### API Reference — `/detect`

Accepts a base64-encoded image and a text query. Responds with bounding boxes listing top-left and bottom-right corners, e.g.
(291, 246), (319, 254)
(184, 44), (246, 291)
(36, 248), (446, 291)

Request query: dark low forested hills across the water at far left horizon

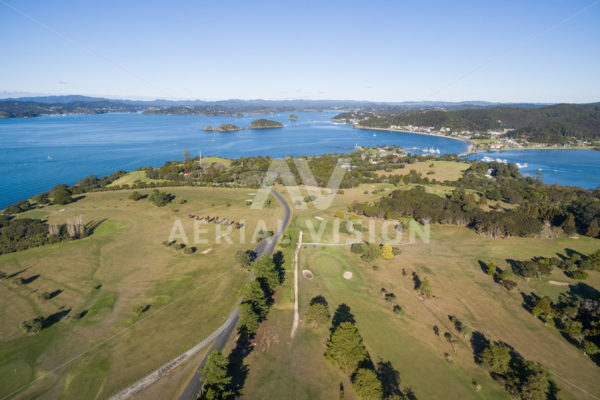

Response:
(0, 99), (140, 118)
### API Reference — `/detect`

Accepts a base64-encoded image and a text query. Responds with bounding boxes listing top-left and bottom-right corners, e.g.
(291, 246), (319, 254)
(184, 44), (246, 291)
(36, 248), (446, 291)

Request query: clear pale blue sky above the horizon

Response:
(0, 0), (600, 102)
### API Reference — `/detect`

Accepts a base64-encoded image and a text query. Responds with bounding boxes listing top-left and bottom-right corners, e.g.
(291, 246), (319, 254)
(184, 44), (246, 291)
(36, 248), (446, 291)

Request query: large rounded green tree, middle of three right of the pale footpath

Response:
(325, 322), (368, 374)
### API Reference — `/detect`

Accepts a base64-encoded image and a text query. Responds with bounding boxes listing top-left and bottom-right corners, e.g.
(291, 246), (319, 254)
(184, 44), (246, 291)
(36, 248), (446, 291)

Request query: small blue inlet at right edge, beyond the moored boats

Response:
(469, 150), (600, 189)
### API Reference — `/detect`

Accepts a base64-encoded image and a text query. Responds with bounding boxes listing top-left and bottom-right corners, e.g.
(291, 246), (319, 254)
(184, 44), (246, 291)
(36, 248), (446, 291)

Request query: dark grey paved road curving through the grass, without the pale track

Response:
(179, 189), (290, 400)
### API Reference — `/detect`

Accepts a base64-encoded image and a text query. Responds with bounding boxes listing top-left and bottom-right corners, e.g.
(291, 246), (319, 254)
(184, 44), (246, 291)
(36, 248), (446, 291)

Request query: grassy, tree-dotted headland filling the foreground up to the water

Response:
(0, 146), (600, 399)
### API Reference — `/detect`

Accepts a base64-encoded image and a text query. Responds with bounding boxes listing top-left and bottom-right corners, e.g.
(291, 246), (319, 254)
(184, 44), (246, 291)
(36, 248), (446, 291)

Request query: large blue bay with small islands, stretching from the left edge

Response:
(0, 112), (466, 208)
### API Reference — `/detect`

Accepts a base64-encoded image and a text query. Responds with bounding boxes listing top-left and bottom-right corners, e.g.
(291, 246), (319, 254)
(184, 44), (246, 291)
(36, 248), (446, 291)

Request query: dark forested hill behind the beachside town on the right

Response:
(335, 103), (600, 143)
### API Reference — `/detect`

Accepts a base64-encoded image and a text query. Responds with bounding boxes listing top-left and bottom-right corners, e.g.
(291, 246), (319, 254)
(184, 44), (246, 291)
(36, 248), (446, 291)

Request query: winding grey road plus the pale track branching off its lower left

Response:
(109, 189), (290, 400)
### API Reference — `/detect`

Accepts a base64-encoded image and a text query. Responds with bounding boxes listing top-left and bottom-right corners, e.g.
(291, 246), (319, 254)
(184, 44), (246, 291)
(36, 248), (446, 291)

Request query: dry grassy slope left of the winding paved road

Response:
(0, 188), (281, 399)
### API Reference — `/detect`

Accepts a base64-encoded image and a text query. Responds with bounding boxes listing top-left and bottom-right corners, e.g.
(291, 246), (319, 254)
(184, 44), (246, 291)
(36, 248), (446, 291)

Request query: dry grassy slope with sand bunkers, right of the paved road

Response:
(238, 190), (600, 399)
